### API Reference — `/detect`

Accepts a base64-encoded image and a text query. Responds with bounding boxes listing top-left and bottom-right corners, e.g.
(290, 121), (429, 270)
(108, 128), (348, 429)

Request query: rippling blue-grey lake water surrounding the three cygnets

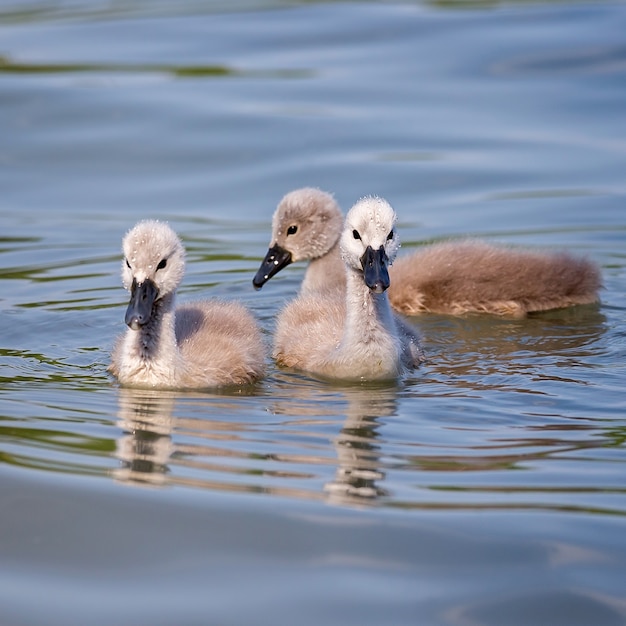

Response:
(0, 0), (626, 626)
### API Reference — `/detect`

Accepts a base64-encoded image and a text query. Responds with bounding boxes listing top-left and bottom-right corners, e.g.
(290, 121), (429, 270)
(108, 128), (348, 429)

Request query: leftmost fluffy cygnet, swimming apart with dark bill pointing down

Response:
(109, 220), (265, 388)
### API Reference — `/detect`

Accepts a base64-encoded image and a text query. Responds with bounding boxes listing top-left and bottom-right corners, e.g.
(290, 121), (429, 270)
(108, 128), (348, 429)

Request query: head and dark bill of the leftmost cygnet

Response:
(122, 220), (185, 330)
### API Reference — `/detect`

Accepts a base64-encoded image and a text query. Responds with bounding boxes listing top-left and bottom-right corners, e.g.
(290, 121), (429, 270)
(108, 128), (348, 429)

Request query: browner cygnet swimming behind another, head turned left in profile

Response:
(253, 188), (601, 317)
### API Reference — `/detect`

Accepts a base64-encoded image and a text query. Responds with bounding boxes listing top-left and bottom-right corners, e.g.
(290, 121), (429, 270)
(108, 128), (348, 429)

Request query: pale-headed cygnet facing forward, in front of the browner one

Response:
(274, 197), (422, 380)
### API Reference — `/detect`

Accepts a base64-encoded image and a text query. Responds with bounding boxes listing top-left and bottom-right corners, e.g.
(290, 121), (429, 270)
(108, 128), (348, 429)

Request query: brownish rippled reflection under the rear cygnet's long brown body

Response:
(414, 305), (607, 395)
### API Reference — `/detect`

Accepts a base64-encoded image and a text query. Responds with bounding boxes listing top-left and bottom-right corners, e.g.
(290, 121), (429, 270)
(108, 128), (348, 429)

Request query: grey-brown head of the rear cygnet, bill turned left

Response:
(252, 187), (343, 289)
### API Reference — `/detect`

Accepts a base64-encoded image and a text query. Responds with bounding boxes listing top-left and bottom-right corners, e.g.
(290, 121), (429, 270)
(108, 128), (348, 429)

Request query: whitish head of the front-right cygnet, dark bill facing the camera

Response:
(340, 197), (400, 293)
